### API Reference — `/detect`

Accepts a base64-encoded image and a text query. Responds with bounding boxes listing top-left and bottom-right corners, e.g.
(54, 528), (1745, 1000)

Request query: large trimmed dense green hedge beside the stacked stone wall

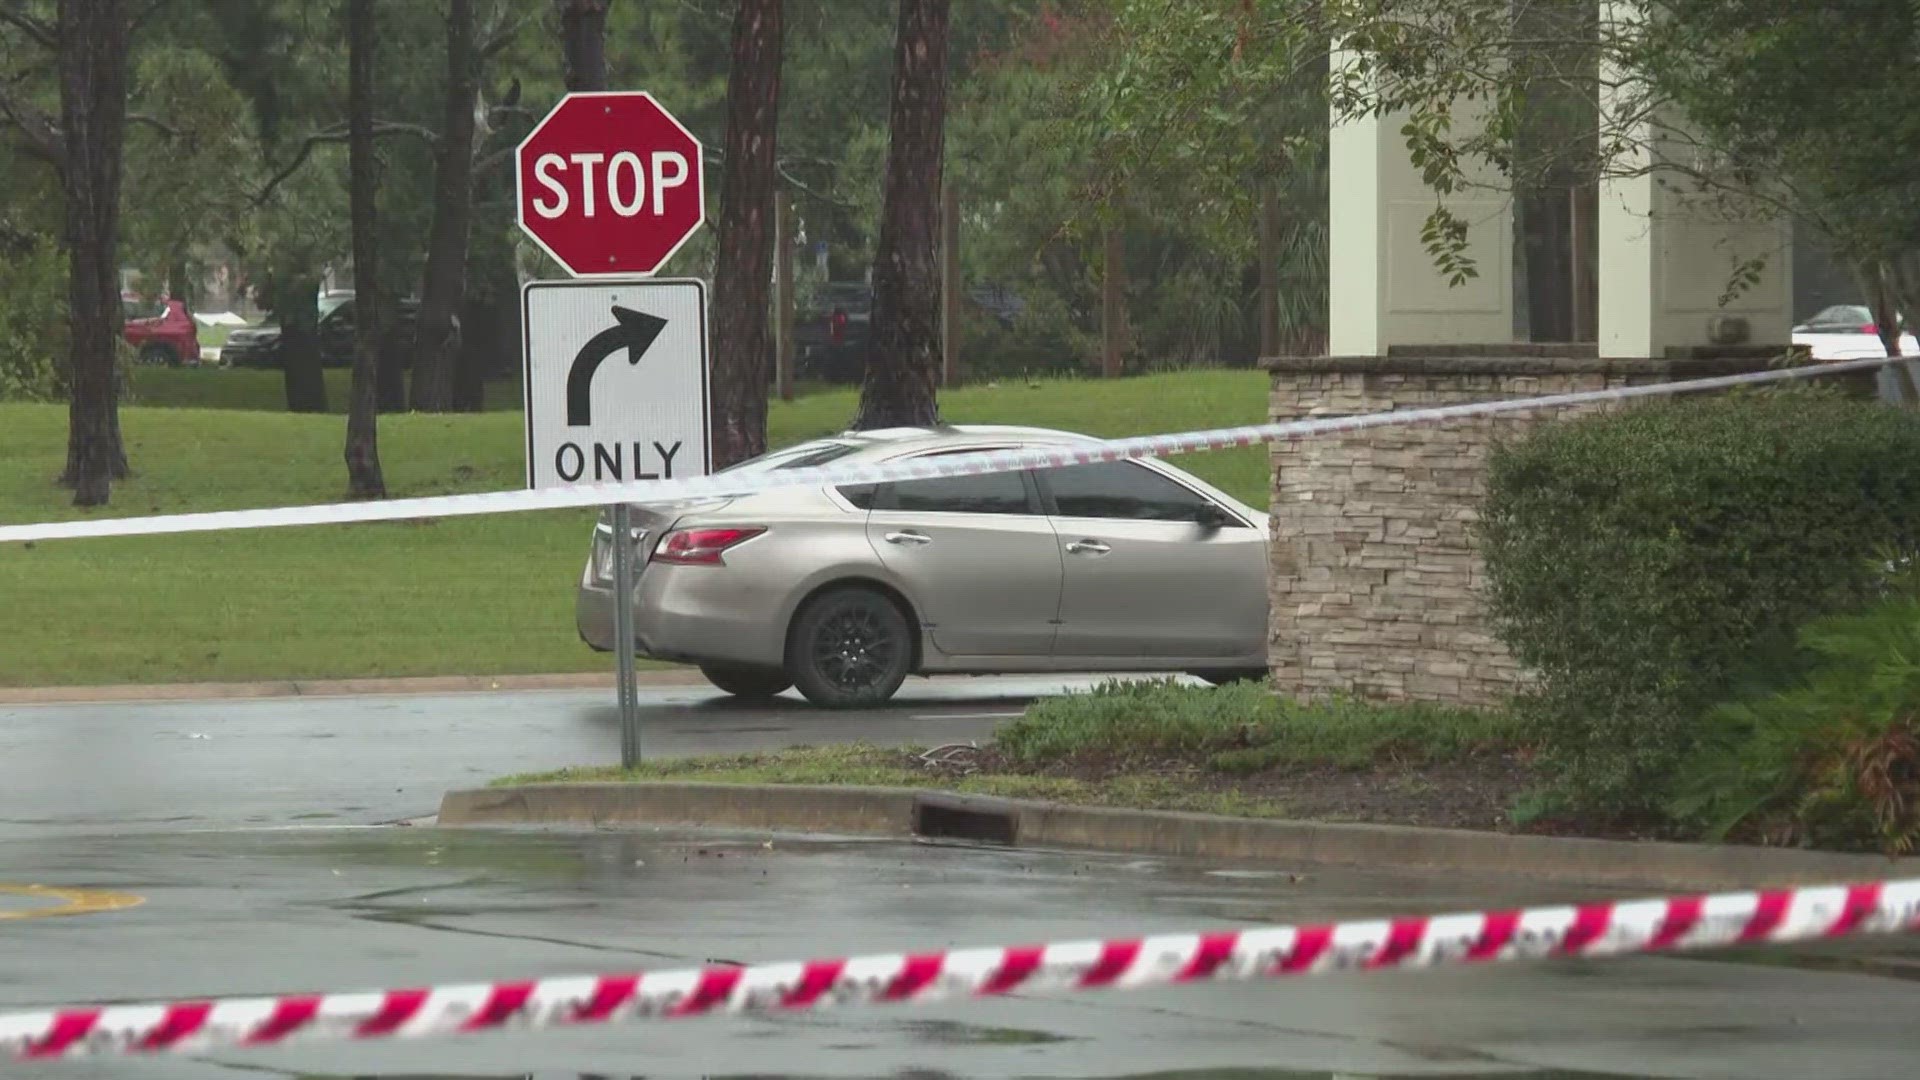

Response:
(1480, 388), (1920, 821)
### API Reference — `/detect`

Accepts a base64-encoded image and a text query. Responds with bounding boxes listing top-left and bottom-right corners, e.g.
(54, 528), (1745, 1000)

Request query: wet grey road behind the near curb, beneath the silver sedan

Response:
(0, 678), (1091, 836)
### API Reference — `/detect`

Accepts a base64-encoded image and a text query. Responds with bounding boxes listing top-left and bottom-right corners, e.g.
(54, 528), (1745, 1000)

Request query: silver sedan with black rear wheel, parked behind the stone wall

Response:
(576, 427), (1267, 709)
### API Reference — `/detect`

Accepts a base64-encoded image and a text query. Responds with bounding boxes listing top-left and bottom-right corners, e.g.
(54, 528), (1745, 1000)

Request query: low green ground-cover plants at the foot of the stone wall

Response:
(995, 680), (1521, 774)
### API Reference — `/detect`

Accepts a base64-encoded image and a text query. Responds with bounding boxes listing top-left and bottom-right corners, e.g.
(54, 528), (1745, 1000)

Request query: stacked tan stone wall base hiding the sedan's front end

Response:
(1267, 346), (1797, 705)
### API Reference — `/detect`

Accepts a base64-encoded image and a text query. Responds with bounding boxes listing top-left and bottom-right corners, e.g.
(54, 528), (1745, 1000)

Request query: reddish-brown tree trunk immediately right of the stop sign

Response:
(712, 0), (783, 469)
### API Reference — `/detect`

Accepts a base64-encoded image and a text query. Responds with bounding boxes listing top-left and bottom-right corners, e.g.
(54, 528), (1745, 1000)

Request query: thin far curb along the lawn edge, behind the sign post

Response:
(0, 669), (705, 705)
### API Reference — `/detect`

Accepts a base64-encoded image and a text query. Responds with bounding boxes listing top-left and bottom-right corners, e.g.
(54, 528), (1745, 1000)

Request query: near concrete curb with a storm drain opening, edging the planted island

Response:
(438, 782), (1920, 890)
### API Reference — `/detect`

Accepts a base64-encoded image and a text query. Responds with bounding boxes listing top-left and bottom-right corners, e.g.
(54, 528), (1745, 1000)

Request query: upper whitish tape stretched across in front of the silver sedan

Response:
(0, 357), (1893, 544)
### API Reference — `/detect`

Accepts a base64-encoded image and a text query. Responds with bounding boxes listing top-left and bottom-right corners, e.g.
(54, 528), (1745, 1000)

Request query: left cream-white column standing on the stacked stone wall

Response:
(1327, 60), (1513, 356)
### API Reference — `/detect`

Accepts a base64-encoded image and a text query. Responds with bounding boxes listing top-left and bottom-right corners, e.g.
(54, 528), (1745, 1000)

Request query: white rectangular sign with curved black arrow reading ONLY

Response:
(522, 279), (712, 488)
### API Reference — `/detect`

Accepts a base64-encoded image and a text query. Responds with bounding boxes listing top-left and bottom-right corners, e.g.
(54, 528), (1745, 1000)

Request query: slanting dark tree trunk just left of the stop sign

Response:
(413, 0), (480, 413)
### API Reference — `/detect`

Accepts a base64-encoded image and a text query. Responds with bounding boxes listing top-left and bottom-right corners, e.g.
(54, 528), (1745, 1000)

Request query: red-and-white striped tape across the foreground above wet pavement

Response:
(0, 868), (1920, 1059)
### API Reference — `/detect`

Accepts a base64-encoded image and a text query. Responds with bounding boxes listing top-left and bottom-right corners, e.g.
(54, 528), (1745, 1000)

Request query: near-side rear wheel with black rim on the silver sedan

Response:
(787, 588), (914, 709)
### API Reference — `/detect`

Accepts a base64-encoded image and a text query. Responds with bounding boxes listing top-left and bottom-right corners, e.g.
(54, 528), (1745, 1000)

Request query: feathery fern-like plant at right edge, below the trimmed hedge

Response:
(1670, 573), (1920, 855)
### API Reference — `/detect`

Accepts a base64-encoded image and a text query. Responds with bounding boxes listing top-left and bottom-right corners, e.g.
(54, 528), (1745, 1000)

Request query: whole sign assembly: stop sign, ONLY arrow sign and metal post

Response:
(515, 92), (712, 769)
